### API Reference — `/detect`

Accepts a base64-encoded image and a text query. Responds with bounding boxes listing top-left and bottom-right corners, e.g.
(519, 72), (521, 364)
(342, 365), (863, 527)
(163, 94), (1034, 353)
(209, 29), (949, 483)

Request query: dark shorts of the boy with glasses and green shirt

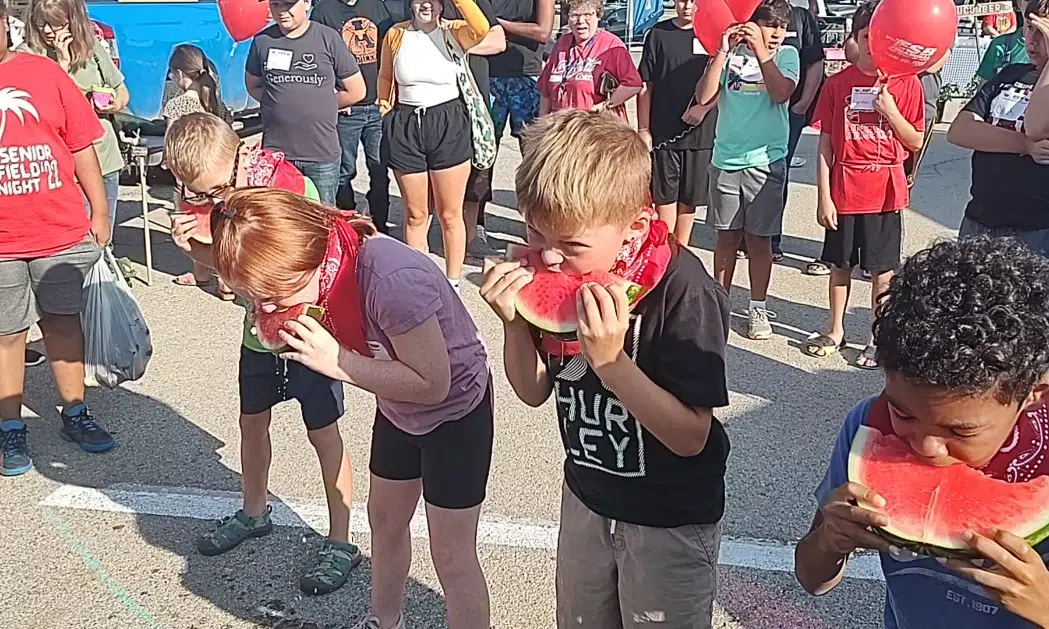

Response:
(239, 346), (346, 430)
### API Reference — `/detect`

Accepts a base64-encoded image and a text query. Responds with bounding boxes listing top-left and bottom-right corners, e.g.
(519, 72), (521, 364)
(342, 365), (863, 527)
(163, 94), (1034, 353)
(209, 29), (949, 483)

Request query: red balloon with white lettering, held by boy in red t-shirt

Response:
(870, 0), (958, 77)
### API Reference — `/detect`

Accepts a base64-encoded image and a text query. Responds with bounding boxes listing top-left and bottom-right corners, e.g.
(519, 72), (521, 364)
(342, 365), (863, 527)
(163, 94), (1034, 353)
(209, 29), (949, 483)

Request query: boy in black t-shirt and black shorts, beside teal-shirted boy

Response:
(638, 0), (716, 244)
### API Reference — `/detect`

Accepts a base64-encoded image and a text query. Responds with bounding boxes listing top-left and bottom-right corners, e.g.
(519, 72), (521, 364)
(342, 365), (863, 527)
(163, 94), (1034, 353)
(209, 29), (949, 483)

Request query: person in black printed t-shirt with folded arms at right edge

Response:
(947, 0), (1049, 256)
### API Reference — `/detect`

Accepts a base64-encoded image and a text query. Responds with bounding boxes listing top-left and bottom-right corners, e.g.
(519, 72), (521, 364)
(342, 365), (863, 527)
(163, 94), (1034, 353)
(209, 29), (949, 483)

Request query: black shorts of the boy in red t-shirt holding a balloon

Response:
(819, 212), (903, 273)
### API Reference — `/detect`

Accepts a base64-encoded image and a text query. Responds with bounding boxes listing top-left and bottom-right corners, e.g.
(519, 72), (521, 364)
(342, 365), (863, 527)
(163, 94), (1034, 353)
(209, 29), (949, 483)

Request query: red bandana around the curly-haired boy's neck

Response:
(865, 396), (1049, 482)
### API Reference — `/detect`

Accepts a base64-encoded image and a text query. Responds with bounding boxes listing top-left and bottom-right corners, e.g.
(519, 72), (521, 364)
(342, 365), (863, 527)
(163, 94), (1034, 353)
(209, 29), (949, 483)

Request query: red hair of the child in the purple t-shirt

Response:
(211, 188), (376, 299)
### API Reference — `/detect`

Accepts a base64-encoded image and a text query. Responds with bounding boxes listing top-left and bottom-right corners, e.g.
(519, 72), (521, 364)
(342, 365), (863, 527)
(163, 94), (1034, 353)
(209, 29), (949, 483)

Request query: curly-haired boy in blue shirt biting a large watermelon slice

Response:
(794, 237), (1049, 629)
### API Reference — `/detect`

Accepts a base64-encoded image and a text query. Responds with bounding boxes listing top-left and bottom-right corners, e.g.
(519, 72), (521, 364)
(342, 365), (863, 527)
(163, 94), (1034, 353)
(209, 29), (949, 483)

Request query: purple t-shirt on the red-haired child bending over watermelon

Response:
(357, 236), (488, 435)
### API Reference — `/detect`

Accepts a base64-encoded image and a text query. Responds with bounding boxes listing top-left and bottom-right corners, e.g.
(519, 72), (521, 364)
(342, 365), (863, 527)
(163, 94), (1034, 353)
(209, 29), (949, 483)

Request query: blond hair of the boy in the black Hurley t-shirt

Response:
(516, 110), (651, 234)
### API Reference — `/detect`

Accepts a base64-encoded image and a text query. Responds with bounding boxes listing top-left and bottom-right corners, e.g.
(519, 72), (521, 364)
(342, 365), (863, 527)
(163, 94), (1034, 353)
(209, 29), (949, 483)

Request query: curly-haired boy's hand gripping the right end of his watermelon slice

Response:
(946, 530), (1049, 627)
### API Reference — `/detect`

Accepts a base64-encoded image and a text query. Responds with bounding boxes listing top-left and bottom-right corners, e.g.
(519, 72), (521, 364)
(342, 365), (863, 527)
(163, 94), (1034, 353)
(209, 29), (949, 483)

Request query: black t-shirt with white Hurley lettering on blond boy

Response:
(547, 248), (729, 528)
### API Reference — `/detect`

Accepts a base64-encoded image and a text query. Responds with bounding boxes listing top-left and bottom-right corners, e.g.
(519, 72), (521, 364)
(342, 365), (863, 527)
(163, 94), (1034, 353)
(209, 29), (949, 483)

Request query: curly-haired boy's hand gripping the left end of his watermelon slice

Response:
(811, 482), (890, 556)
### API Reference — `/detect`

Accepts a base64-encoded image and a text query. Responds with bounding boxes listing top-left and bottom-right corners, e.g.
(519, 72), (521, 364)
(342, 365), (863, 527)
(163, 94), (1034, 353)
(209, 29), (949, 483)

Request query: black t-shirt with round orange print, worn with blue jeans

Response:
(309, 0), (395, 105)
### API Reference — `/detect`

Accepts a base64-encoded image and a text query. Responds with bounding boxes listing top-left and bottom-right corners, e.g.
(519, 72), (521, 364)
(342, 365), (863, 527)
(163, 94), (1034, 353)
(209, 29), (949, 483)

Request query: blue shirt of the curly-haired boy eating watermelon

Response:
(815, 397), (1049, 629)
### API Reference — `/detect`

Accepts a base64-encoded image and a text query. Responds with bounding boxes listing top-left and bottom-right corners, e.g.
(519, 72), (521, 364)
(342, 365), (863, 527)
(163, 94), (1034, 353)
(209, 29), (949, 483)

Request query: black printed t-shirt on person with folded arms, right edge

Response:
(965, 63), (1049, 231)
